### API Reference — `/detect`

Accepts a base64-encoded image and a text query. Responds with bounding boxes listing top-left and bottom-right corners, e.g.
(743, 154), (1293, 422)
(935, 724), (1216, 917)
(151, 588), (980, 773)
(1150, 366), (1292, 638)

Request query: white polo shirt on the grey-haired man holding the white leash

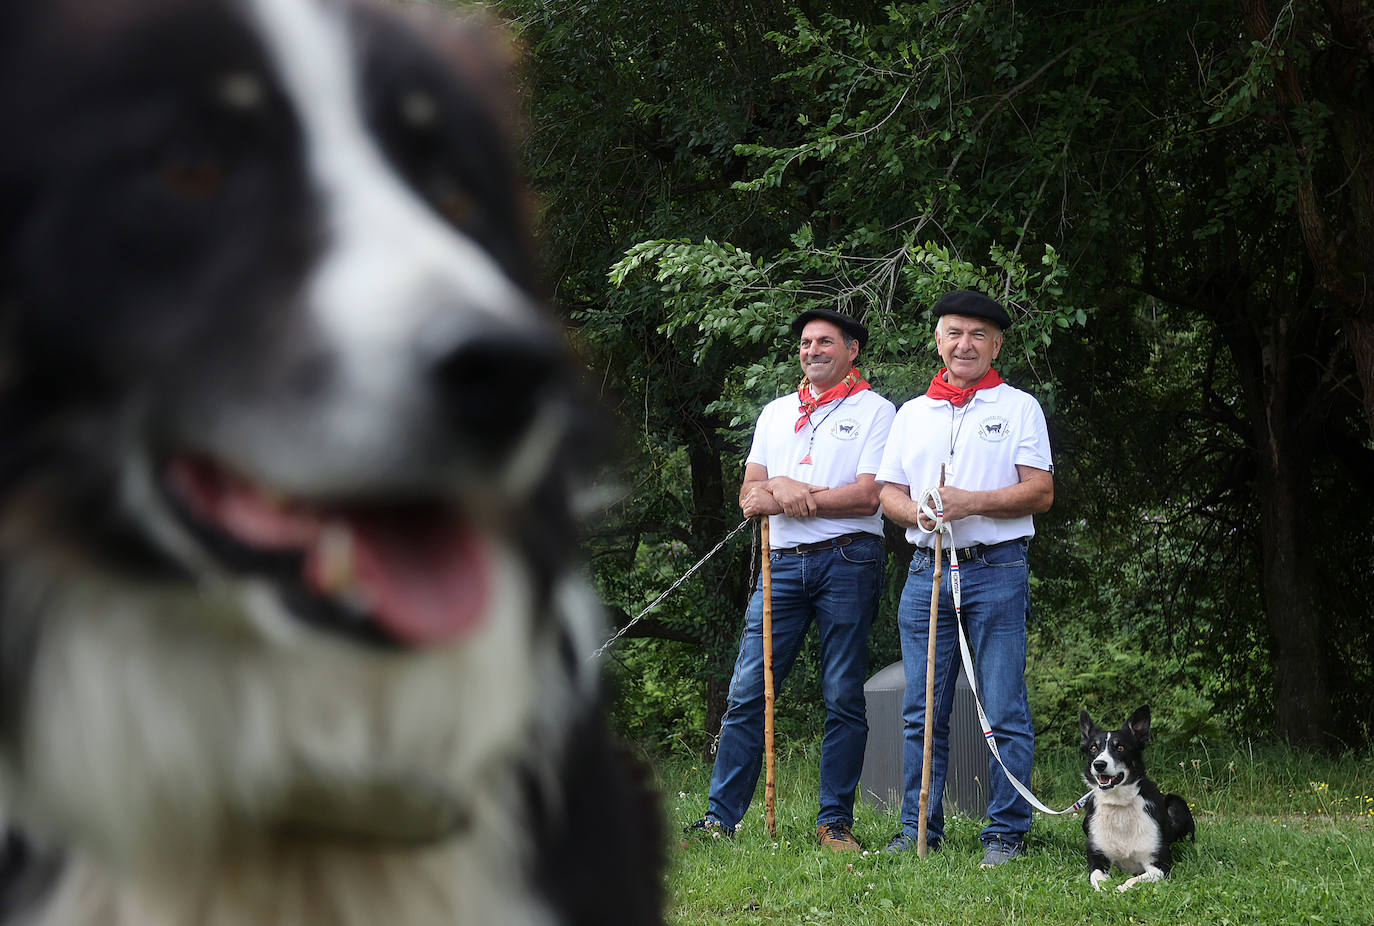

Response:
(878, 383), (1054, 548)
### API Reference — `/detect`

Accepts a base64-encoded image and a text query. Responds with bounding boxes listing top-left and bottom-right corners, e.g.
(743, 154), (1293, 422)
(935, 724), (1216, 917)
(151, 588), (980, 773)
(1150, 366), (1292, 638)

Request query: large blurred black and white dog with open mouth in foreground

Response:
(0, 0), (661, 926)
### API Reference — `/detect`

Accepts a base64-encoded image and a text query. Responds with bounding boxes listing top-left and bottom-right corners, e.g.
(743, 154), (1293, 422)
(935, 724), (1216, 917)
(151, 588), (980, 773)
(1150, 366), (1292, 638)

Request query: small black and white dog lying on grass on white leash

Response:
(1079, 705), (1194, 890)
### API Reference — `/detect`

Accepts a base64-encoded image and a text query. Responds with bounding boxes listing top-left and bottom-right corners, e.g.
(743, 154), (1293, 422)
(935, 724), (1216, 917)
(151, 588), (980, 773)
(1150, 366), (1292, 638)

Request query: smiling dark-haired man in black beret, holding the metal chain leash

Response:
(687, 309), (896, 852)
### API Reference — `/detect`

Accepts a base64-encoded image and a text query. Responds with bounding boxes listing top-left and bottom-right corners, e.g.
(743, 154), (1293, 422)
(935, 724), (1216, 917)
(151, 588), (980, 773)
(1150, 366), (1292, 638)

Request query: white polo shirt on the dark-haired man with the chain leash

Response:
(747, 389), (897, 548)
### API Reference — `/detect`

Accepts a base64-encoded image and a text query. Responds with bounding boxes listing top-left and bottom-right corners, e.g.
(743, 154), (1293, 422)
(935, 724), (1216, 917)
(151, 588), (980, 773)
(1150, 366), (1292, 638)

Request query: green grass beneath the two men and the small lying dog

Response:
(658, 746), (1374, 926)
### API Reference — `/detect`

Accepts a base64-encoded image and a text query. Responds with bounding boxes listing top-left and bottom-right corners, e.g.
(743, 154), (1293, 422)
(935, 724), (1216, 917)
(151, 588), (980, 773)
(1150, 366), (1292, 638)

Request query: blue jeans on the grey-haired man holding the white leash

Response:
(897, 540), (1035, 842)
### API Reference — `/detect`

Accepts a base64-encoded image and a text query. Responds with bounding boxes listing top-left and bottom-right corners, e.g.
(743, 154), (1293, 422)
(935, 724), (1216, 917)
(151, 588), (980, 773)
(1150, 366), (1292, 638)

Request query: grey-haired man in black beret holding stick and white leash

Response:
(878, 290), (1054, 867)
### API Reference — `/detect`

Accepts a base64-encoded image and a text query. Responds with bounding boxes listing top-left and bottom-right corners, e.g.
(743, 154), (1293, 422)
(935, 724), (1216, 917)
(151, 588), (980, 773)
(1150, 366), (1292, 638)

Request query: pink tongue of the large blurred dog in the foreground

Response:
(346, 515), (491, 646)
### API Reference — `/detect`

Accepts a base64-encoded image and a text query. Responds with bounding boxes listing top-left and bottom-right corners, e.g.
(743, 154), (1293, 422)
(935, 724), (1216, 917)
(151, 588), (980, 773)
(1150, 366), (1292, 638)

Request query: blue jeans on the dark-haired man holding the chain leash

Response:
(706, 536), (883, 827)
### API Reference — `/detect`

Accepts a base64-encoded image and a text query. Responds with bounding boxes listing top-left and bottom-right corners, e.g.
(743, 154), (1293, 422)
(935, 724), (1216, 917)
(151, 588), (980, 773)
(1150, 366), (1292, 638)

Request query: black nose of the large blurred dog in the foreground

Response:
(430, 323), (567, 455)
